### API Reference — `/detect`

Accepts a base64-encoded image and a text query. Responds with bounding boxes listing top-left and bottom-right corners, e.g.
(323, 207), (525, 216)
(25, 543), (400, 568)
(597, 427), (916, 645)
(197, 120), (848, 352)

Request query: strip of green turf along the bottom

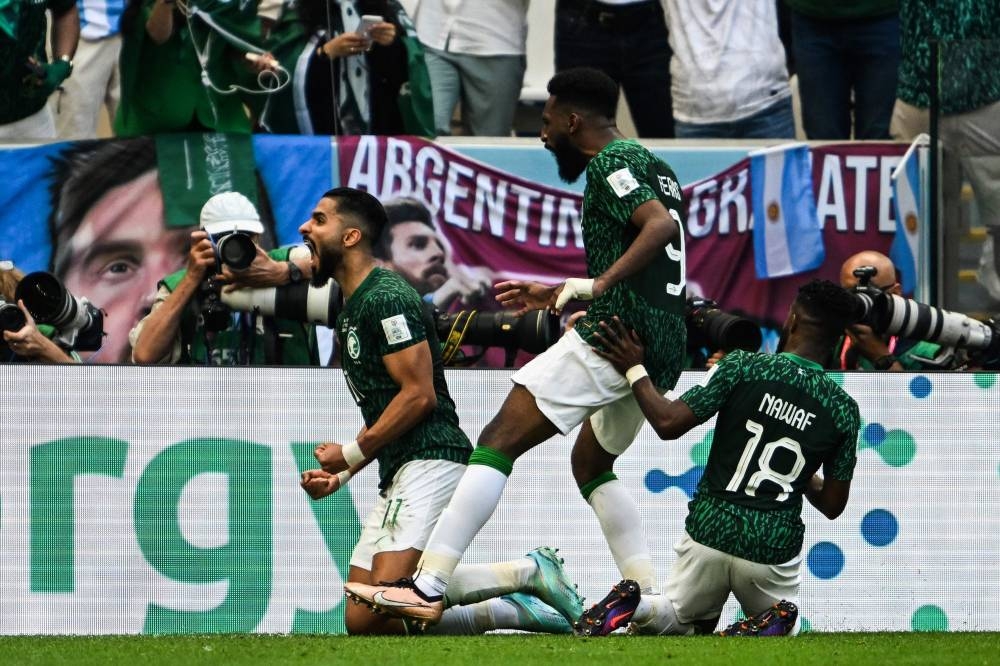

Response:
(0, 633), (1000, 666)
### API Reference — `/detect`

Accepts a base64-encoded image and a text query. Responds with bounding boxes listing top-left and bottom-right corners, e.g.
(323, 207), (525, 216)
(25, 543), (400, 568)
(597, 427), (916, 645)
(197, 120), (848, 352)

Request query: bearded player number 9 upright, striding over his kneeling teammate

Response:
(345, 68), (686, 623)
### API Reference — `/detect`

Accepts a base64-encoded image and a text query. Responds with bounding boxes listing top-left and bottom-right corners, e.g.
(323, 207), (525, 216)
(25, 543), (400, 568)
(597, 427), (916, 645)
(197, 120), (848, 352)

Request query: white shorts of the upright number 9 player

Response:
(511, 329), (645, 455)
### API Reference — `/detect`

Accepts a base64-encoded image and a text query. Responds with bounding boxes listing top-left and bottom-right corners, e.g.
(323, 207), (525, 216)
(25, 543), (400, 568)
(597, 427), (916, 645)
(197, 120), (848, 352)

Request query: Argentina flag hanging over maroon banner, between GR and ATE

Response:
(750, 143), (826, 280)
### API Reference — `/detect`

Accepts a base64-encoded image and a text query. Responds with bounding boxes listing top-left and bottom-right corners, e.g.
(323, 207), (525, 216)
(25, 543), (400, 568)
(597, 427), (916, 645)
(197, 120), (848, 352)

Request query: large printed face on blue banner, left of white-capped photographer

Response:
(63, 171), (190, 363)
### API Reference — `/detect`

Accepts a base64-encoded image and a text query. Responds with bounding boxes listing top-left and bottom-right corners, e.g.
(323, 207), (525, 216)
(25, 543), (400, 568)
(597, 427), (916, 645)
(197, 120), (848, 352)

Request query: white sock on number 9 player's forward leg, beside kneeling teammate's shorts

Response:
(415, 465), (507, 596)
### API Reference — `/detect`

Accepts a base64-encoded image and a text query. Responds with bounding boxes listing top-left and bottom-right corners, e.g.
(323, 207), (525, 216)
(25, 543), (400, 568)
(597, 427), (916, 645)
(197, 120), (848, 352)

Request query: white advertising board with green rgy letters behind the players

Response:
(0, 365), (1000, 634)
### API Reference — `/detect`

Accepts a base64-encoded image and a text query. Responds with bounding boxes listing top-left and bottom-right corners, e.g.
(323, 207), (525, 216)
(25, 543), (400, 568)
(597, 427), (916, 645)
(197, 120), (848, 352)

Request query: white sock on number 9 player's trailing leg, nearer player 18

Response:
(587, 479), (659, 594)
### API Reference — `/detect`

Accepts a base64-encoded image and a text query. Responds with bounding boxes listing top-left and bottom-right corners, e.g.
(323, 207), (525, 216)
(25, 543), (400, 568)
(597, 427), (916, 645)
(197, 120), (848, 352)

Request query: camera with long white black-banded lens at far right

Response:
(852, 266), (1000, 356)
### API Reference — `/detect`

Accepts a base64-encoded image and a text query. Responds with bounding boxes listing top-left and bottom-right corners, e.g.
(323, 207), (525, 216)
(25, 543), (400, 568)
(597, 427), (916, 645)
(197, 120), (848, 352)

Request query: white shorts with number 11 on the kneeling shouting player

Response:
(351, 460), (465, 571)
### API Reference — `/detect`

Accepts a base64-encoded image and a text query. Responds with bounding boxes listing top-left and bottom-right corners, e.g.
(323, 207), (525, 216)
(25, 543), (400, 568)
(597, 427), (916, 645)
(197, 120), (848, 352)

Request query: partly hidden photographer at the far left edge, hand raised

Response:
(0, 261), (79, 363)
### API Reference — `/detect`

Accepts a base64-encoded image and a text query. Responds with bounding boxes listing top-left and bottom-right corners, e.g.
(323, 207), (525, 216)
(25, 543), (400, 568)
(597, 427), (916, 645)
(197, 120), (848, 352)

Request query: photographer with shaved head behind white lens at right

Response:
(828, 250), (950, 372)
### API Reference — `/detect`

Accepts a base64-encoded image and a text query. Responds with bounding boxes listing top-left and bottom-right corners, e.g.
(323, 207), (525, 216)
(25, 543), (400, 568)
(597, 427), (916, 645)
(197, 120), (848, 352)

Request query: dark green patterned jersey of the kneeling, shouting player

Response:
(337, 268), (472, 488)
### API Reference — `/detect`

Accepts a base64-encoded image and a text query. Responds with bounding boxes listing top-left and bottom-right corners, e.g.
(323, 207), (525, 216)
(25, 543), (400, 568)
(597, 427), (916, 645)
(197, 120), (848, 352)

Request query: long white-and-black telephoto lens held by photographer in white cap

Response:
(220, 280), (340, 327)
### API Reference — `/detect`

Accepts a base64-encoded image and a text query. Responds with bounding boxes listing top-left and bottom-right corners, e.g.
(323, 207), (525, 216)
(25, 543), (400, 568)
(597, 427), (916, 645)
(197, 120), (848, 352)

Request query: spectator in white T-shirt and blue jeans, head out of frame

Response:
(666, 0), (795, 139)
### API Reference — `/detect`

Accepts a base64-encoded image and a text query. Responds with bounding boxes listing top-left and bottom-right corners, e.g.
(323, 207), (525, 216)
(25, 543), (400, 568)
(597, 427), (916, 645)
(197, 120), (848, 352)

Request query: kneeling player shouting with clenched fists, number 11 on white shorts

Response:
(299, 187), (583, 634)
